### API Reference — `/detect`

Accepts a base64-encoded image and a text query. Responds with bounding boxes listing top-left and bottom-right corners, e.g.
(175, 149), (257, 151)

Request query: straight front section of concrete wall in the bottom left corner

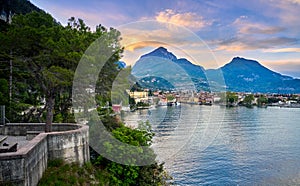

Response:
(0, 133), (48, 185)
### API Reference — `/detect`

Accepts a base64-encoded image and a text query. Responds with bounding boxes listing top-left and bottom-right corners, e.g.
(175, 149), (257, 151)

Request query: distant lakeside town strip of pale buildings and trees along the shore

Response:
(112, 89), (300, 113)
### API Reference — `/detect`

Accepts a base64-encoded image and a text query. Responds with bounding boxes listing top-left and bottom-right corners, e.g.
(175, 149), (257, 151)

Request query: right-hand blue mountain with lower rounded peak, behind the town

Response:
(206, 57), (300, 93)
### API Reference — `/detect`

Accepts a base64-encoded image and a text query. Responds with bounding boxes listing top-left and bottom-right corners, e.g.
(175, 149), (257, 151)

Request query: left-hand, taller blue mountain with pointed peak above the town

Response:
(132, 47), (208, 89)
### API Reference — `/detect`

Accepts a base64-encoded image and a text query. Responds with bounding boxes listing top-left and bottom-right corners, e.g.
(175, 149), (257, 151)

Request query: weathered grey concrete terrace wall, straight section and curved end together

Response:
(0, 124), (89, 186)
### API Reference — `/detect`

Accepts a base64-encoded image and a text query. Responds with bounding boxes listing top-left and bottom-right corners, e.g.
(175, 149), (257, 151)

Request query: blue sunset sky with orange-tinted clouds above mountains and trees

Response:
(31, 0), (300, 78)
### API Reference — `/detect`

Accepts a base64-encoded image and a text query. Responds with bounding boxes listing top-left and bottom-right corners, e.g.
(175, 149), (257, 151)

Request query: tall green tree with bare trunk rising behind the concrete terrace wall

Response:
(4, 12), (73, 132)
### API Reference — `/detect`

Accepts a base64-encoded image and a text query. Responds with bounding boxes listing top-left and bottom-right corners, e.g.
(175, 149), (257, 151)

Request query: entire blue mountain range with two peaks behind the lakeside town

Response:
(132, 47), (300, 93)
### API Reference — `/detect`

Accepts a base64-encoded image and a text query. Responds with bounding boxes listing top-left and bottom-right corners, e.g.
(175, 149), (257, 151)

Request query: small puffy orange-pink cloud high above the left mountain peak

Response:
(155, 9), (211, 29)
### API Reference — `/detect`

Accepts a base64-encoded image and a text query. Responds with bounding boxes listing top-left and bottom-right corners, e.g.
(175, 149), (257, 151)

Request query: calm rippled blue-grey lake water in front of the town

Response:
(123, 104), (300, 185)
